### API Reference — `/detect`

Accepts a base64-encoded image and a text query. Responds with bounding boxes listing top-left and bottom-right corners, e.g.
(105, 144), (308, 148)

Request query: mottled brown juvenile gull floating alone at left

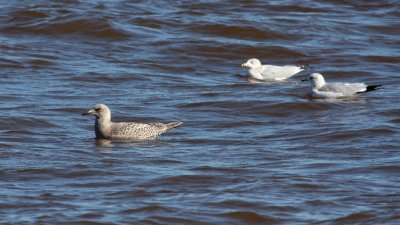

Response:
(82, 104), (182, 141)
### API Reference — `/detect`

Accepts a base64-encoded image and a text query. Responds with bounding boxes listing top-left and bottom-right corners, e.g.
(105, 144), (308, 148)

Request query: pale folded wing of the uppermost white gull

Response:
(261, 65), (303, 80)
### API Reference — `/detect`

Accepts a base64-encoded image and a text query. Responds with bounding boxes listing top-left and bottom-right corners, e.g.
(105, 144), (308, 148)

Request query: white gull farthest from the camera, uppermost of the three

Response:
(242, 58), (306, 81)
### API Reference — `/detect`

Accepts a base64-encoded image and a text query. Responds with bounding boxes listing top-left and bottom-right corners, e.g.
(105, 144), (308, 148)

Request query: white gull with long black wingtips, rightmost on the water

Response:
(302, 73), (382, 98)
